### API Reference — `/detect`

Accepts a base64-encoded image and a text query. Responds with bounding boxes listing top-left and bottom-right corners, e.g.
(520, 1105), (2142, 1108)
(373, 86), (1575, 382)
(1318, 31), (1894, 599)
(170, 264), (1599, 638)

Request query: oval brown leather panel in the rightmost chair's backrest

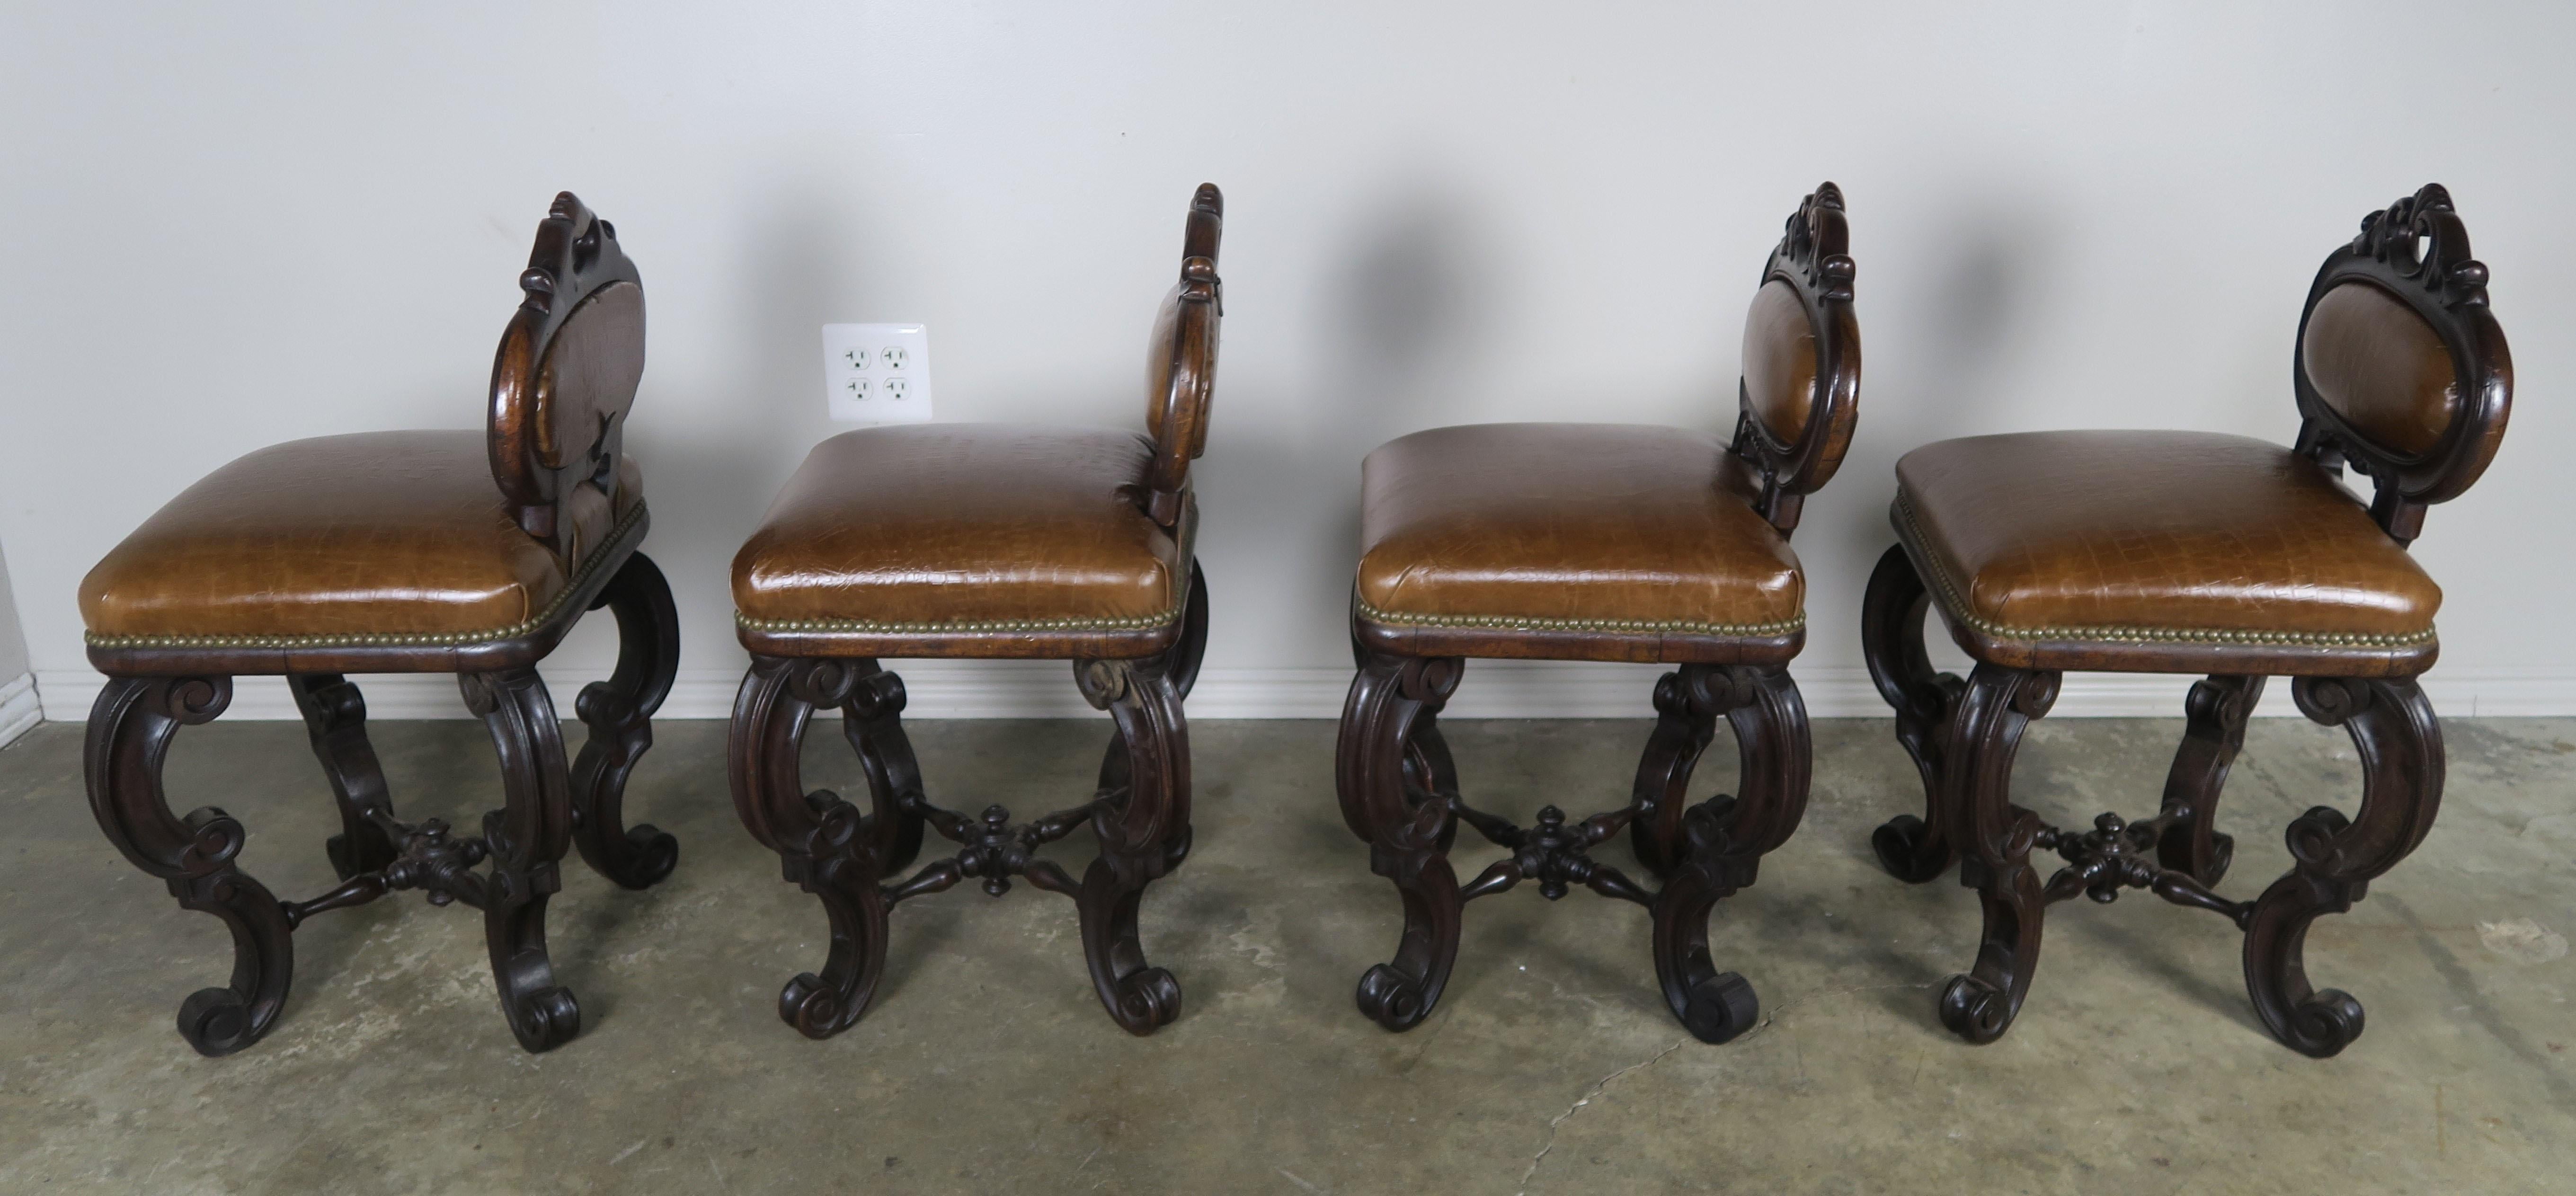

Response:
(2298, 283), (2460, 454)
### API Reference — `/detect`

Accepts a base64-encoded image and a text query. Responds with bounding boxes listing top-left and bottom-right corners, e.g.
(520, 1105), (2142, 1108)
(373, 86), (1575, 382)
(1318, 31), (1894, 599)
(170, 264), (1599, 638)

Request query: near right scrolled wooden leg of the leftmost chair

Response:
(456, 668), (582, 1052)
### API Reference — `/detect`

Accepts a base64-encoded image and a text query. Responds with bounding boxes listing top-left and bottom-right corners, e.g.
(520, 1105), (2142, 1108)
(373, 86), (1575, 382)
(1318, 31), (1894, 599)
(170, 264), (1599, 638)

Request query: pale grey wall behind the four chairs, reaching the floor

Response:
(0, 0), (2576, 717)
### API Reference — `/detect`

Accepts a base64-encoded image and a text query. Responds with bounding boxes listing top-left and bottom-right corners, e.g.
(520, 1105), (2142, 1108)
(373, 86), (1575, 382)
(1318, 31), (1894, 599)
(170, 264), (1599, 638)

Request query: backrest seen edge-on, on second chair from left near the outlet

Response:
(1144, 183), (1226, 528)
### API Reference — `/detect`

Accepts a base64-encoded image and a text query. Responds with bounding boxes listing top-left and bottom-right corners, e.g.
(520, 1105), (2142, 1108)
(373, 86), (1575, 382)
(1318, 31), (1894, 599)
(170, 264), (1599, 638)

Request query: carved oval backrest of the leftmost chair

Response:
(489, 191), (644, 559)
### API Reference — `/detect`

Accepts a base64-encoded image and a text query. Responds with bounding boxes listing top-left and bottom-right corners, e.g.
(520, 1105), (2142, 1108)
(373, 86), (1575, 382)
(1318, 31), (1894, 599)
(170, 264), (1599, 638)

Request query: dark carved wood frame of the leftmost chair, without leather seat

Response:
(85, 191), (680, 1054)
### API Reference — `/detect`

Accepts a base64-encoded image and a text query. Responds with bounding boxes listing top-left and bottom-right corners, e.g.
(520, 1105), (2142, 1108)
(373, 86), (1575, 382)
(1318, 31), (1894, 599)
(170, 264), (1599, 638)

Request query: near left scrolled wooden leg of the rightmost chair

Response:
(1940, 665), (2058, 1044)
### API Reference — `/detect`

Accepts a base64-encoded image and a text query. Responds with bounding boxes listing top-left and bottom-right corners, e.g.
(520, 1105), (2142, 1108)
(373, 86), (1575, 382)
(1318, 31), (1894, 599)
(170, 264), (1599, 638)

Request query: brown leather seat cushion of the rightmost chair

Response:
(1896, 431), (2442, 668)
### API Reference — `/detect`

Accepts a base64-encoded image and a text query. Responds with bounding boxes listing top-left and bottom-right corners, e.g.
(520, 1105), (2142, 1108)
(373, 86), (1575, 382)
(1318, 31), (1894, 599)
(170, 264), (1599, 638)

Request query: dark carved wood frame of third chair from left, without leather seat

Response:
(1334, 183), (1860, 1041)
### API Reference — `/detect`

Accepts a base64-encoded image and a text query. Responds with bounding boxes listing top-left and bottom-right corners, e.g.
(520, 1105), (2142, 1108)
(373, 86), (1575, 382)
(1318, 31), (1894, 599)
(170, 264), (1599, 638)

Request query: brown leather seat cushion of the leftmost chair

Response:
(80, 431), (644, 647)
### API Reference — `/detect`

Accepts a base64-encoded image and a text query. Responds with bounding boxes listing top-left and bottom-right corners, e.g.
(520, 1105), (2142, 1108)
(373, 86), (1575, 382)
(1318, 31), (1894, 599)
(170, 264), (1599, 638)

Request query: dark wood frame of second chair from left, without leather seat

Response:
(729, 186), (1224, 1039)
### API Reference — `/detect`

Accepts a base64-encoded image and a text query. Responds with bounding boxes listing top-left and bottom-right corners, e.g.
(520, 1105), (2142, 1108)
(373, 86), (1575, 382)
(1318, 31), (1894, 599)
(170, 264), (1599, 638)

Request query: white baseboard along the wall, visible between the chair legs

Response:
(35, 660), (2576, 721)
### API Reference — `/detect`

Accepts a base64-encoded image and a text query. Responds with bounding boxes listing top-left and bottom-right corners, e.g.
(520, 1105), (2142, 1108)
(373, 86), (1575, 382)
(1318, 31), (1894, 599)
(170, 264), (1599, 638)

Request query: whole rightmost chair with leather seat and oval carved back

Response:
(1863, 186), (2514, 1057)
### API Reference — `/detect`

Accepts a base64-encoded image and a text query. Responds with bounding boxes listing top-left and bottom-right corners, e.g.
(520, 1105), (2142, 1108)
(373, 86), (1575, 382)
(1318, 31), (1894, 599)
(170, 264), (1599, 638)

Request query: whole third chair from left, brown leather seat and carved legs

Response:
(1334, 183), (1860, 1041)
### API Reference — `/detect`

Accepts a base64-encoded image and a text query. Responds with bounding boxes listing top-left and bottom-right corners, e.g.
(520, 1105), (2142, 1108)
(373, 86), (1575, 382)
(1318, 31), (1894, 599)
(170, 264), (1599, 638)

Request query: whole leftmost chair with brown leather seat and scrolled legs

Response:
(80, 191), (680, 1054)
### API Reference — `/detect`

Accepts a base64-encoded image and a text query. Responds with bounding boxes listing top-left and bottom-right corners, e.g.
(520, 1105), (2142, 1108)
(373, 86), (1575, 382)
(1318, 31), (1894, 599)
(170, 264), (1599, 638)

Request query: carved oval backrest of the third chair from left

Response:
(1733, 183), (1860, 533)
